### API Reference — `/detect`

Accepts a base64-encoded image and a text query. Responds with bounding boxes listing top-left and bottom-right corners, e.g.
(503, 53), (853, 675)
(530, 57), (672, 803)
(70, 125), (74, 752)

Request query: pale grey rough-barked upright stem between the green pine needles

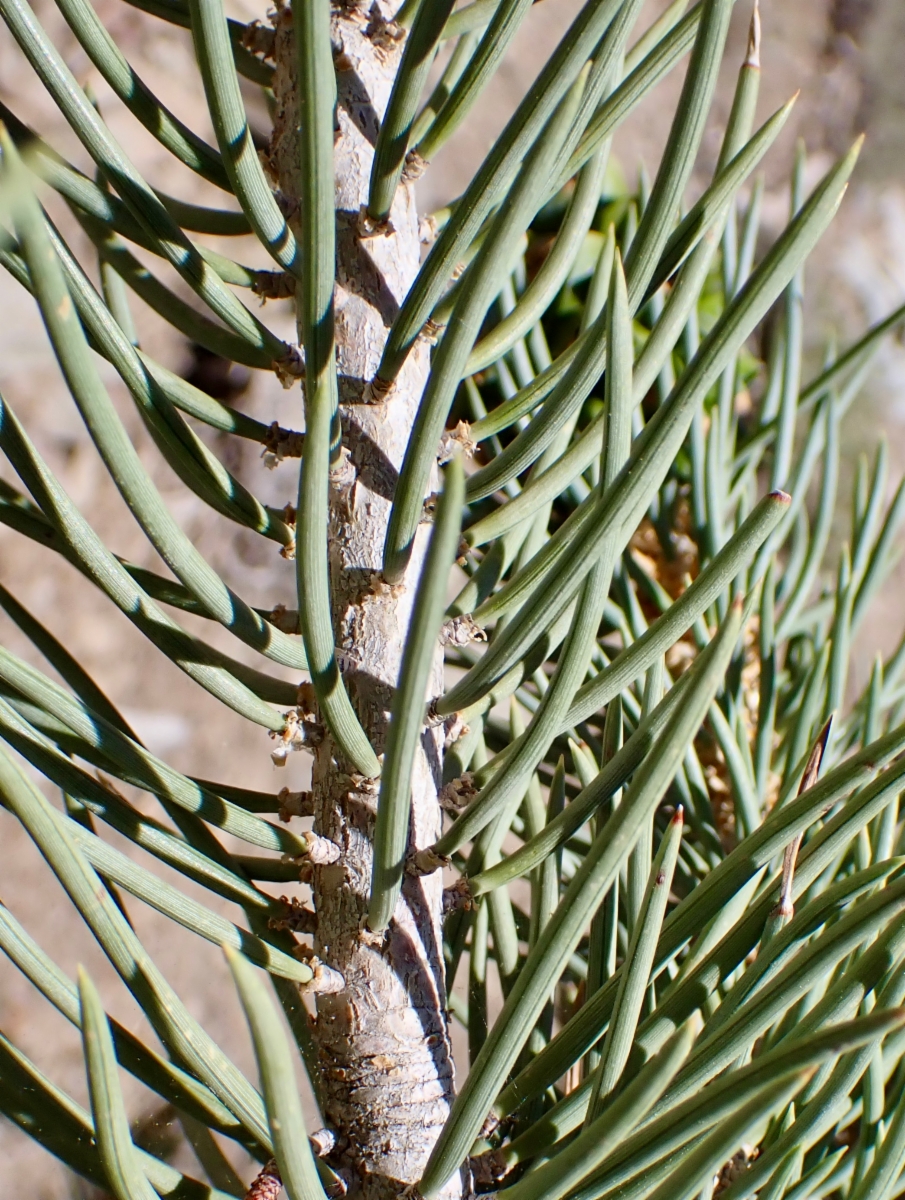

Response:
(269, 0), (453, 1200)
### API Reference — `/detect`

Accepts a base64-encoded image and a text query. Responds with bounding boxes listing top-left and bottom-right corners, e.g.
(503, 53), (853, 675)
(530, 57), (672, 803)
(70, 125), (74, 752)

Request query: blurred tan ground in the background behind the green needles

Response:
(0, 0), (905, 1200)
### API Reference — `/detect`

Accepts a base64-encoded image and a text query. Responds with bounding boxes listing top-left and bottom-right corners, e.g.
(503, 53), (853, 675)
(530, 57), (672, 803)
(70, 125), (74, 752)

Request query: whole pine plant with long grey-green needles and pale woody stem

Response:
(0, 0), (905, 1200)
